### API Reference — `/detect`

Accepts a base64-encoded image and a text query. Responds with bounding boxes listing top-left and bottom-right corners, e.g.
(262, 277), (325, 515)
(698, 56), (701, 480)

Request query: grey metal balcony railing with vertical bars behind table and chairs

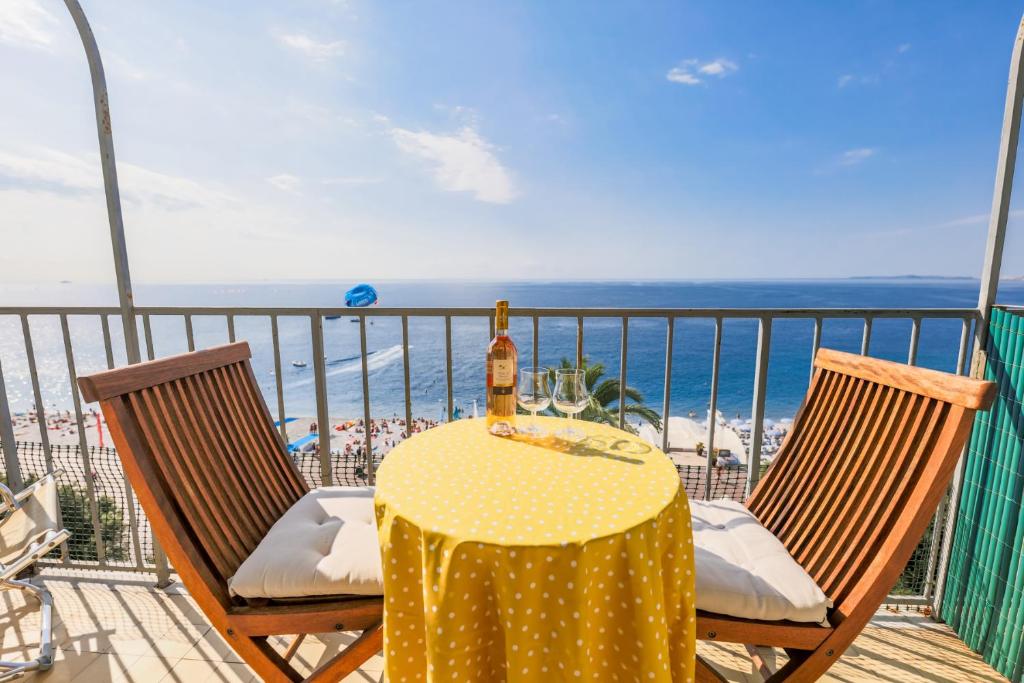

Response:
(0, 306), (979, 602)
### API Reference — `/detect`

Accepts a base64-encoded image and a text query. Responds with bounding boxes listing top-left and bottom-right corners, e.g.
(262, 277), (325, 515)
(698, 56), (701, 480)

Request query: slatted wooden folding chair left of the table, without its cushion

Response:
(79, 342), (383, 682)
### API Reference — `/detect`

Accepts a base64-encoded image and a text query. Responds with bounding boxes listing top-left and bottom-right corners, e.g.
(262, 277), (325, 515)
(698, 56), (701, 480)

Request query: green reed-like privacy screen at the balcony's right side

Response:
(942, 309), (1024, 682)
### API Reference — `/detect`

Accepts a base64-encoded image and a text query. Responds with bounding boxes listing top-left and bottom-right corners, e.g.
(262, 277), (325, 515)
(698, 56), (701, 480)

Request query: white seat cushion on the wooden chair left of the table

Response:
(227, 486), (384, 598)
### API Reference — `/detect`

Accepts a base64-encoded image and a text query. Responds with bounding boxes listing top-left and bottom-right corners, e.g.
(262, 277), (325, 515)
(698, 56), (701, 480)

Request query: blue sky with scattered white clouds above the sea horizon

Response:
(0, 0), (1024, 283)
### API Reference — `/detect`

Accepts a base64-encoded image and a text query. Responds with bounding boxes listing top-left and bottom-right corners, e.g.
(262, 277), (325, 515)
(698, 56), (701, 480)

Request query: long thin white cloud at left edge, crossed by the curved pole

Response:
(0, 147), (233, 210)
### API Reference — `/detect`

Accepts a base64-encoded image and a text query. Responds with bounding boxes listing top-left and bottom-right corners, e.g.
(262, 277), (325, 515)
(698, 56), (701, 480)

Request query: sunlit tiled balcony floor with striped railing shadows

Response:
(0, 572), (1006, 683)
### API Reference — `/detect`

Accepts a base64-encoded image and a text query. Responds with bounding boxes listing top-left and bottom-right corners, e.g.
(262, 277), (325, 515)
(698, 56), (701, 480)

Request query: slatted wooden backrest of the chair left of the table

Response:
(79, 342), (308, 605)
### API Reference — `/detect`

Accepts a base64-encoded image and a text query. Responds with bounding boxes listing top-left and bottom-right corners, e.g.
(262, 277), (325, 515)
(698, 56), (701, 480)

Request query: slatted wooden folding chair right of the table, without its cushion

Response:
(697, 349), (996, 682)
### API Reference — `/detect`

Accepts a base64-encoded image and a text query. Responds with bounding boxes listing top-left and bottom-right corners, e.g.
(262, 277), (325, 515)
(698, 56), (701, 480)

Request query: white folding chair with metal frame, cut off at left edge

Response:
(0, 472), (71, 681)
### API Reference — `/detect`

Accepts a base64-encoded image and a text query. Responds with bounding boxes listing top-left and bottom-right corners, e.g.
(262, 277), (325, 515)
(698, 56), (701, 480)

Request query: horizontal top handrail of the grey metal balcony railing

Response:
(114, 306), (978, 319)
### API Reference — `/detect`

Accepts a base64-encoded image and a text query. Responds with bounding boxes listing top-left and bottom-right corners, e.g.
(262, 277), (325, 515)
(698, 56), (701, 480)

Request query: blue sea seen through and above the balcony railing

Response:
(0, 278), (1024, 420)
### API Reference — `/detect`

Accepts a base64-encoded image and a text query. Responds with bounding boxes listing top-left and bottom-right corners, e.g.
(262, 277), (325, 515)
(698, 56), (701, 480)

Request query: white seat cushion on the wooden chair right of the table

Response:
(690, 500), (831, 625)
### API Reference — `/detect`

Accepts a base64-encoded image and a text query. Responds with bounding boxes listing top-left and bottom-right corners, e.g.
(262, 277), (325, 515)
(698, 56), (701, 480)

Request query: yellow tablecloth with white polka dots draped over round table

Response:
(375, 418), (696, 683)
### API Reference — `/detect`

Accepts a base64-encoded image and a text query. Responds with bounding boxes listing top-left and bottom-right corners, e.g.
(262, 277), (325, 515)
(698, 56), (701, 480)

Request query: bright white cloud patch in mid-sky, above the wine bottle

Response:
(390, 126), (518, 204)
